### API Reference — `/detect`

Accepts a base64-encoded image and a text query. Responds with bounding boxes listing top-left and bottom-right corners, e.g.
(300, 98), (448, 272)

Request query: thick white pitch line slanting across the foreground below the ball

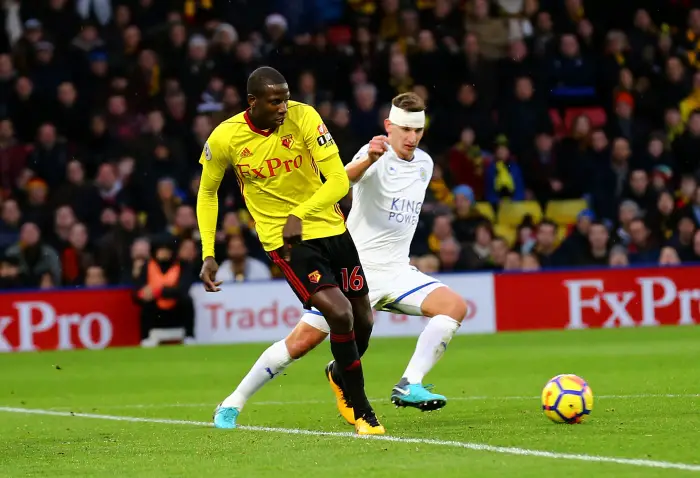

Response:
(0, 407), (700, 472)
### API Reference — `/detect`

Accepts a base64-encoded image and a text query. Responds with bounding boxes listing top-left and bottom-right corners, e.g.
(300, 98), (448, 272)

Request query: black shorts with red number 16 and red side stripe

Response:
(268, 231), (369, 309)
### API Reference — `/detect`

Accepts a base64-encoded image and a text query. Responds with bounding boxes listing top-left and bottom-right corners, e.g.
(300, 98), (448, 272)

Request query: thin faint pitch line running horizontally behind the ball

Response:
(42, 393), (700, 410)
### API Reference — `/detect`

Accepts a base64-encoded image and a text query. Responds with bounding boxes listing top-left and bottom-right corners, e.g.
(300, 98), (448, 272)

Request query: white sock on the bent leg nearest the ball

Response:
(403, 315), (461, 383)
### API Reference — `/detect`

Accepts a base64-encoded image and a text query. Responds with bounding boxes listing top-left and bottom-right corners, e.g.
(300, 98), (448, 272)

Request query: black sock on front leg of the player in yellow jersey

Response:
(331, 332), (372, 418)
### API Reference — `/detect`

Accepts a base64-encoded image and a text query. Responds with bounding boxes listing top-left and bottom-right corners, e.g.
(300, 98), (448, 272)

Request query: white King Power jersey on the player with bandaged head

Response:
(347, 144), (433, 270)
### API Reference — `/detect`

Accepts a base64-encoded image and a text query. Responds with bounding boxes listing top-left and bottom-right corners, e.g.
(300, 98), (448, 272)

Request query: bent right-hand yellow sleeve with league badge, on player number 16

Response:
(290, 106), (350, 220)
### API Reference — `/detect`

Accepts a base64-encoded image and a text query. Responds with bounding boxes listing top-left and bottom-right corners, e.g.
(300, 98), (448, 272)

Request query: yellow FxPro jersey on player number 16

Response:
(198, 101), (347, 257)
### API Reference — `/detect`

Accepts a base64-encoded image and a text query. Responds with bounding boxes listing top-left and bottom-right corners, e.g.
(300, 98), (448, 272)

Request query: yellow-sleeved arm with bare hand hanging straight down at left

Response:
(197, 131), (226, 292)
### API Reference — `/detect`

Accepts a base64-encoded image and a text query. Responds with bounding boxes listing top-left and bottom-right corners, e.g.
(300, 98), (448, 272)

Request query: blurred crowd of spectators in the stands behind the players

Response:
(0, 0), (700, 288)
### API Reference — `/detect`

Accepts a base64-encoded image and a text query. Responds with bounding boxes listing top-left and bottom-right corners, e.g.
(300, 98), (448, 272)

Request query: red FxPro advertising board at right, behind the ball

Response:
(495, 267), (700, 331)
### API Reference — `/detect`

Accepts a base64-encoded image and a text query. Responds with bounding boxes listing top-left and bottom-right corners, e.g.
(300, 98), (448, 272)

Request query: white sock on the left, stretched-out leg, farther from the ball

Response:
(221, 340), (293, 411)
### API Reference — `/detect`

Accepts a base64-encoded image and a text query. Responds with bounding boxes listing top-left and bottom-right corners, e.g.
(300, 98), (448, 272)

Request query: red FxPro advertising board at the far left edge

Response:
(0, 289), (141, 352)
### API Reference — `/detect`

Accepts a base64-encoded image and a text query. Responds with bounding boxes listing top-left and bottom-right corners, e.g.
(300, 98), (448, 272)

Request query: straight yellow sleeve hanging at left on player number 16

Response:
(197, 128), (229, 259)
